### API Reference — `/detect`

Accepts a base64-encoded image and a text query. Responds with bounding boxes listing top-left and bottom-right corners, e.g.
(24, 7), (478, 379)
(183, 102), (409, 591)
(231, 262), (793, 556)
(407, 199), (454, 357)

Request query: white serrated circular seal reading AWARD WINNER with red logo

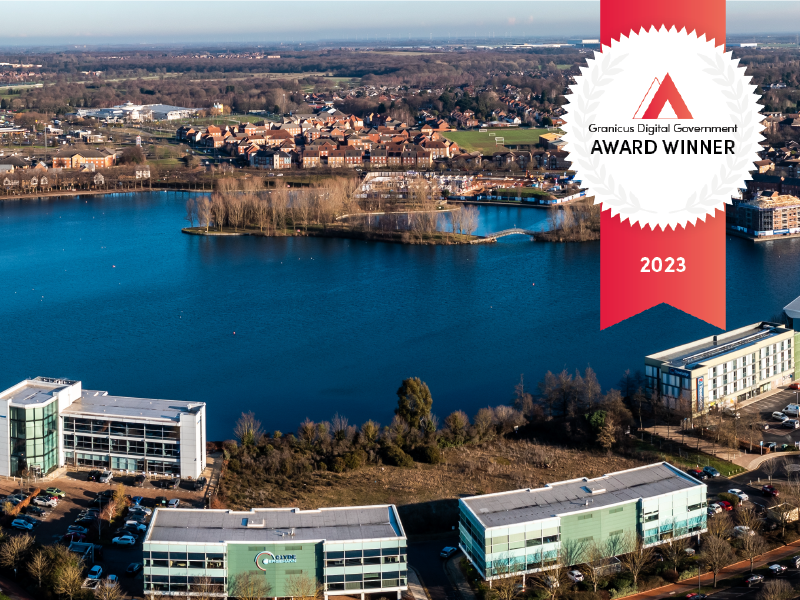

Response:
(563, 27), (763, 229)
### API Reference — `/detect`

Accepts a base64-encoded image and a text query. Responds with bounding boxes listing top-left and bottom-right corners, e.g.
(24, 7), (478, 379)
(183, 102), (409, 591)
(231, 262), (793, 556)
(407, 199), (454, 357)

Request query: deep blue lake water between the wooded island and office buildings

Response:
(0, 193), (800, 439)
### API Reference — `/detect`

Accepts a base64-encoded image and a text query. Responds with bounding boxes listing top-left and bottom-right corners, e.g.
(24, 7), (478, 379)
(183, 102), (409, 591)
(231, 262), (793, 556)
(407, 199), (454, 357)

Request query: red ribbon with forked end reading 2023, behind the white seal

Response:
(600, 0), (725, 329)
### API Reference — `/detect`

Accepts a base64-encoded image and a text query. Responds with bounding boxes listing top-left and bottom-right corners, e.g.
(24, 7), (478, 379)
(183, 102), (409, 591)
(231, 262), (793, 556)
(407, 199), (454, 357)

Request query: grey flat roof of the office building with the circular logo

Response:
(145, 504), (405, 544)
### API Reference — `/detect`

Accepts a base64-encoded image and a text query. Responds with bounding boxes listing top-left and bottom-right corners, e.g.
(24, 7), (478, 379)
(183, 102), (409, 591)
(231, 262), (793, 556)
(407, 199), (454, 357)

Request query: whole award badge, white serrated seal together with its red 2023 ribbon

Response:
(563, 0), (763, 329)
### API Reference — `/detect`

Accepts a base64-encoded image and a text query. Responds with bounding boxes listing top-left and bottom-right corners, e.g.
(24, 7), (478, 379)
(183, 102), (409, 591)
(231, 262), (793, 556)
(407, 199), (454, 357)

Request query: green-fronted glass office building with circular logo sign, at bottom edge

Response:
(143, 505), (408, 600)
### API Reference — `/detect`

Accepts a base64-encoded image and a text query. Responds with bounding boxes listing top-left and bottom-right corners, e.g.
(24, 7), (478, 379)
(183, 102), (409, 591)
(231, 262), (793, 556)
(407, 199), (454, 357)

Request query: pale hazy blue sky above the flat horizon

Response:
(0, 0), (800, 47)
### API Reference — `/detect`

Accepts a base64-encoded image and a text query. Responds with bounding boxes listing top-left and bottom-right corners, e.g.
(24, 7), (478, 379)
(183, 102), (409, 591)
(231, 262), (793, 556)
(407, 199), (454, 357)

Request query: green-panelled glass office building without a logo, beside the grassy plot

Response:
(459, 462), (706, 581)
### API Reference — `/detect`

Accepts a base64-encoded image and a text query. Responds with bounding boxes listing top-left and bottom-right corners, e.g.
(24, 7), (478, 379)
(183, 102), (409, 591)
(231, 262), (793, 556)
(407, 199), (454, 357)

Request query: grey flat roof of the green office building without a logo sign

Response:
(462, 462), (703, 529)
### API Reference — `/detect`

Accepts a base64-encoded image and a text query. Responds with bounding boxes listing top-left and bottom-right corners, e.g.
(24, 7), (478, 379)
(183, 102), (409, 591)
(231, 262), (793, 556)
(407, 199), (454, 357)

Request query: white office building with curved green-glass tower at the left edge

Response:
(0, 377), (206, 479)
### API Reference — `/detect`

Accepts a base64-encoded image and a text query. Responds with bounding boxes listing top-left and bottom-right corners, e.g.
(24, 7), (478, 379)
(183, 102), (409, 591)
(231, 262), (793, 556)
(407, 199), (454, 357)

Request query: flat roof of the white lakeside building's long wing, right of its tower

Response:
(61, 390), (203, 421)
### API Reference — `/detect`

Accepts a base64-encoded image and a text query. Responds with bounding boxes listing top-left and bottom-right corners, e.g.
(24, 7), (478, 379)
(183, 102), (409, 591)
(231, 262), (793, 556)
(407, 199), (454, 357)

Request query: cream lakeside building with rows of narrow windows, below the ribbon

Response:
(644, 321), (795, 415)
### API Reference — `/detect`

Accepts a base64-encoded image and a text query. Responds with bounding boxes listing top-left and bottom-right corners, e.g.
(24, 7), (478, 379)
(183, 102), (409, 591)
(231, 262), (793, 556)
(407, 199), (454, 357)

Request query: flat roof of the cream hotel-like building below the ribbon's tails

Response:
(647, 321), (792, 370)
